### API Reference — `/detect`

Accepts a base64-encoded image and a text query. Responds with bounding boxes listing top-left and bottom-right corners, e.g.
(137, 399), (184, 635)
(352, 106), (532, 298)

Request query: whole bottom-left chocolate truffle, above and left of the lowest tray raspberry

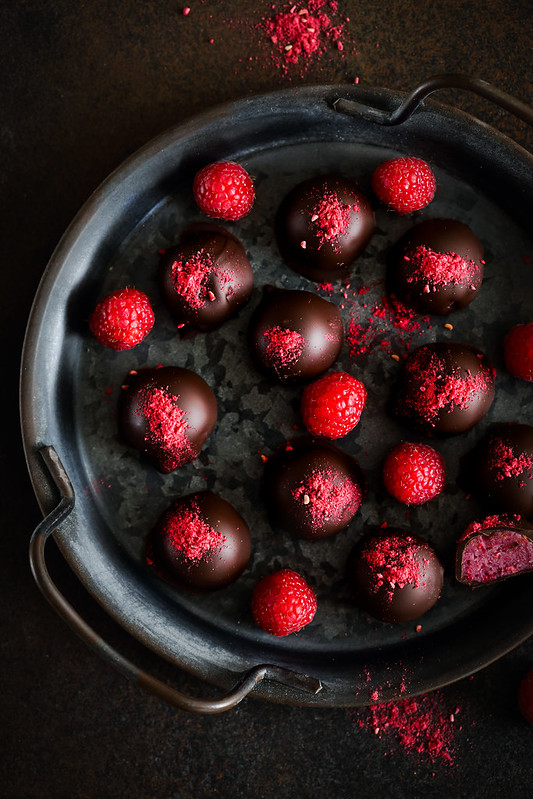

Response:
(146, 491), (252, 591)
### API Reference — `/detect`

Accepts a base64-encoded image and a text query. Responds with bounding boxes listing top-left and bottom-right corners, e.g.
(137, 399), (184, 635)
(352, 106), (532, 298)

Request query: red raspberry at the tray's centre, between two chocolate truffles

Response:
(301, 372), (366, 438)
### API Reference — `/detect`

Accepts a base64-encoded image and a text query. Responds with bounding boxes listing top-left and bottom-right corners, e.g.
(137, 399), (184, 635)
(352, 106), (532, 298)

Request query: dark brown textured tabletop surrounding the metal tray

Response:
(0, 0), (533, 799)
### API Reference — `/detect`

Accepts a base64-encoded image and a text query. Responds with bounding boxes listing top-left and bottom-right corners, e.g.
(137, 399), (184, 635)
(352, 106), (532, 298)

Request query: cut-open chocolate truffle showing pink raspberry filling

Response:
(455, 516), (533, 587)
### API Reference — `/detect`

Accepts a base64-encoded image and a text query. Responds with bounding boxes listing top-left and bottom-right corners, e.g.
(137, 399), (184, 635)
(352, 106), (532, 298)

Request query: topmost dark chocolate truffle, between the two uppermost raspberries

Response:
(275, 175), (375, 283)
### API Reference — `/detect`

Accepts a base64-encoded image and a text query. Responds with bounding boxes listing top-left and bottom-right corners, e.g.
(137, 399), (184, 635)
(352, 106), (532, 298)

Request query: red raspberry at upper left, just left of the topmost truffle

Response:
(192, 161), (255, 221)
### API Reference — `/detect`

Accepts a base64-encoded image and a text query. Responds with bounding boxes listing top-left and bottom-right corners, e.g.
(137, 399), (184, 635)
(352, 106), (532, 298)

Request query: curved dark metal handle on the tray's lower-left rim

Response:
(29, 446), (322, 714)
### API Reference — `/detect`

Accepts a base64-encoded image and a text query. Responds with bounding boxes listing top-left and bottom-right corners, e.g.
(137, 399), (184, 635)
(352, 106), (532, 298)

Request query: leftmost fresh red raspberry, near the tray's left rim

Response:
(89, 288), (154, 350)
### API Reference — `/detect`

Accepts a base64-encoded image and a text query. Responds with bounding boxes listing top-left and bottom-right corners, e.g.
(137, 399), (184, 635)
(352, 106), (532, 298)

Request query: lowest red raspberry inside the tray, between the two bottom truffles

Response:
(252, 569), (317, 636)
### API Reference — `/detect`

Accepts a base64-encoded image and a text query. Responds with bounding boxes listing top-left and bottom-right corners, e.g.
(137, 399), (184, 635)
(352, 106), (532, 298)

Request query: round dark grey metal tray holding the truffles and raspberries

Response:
(21, 79), (533, 712)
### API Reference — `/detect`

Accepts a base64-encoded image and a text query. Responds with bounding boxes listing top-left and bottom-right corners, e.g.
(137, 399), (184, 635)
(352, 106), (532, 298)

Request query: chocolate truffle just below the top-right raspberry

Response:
(388, 219), (483, 316)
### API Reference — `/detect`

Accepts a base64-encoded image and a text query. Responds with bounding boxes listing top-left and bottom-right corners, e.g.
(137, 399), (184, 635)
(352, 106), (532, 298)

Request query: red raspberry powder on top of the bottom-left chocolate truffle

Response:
(158, 502), (226, 560)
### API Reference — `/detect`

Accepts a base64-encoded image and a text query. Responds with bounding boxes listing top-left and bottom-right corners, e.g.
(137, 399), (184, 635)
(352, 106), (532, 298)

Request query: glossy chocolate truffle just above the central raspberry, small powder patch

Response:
(248, 286), (344, 381)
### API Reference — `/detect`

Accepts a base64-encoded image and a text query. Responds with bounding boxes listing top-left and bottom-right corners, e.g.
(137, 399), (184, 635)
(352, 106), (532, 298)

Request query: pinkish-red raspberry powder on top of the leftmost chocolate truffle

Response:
(141, 388), (195, 469)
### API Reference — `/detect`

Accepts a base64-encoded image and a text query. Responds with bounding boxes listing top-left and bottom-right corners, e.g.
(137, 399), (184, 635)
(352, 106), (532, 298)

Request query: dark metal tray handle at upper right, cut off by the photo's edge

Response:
(333, 72), (533, 126)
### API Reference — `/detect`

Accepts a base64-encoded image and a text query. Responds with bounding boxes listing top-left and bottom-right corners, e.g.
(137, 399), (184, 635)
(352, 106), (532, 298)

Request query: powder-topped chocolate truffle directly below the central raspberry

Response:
(264, 438), (366, 540)
